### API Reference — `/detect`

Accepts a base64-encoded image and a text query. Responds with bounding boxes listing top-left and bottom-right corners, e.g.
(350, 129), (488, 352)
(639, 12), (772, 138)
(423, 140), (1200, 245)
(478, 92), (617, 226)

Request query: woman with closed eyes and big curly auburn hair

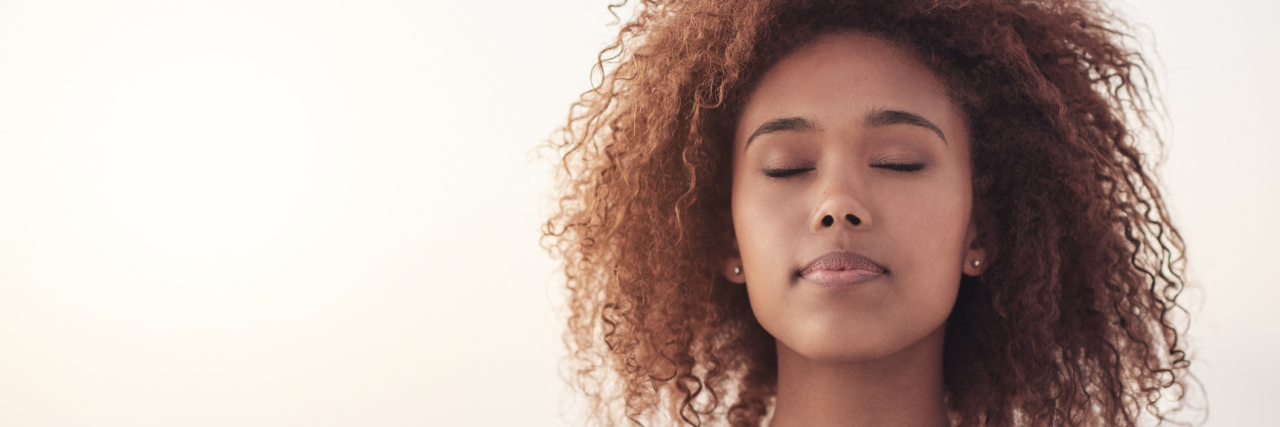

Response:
(545, 0), (1188, 427)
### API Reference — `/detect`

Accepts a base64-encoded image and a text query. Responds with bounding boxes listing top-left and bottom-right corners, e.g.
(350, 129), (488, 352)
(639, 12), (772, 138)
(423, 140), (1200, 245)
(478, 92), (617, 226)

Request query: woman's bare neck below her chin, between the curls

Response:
(769, 327), (951, 427)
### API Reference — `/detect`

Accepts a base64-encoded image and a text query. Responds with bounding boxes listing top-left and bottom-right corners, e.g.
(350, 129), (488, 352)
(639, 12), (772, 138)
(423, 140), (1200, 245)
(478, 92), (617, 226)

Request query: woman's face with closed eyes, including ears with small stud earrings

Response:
(724, 33), (984, 361)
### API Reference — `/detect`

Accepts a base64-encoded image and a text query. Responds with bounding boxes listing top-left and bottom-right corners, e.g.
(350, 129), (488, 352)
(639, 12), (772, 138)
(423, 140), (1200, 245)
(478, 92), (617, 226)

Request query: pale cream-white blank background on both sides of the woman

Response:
(0, 0), (1280, 427)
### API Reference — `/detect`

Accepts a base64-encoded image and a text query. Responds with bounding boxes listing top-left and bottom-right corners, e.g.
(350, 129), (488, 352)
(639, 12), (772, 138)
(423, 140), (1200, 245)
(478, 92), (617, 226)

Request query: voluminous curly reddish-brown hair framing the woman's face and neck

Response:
(543, 0), (1190, 426)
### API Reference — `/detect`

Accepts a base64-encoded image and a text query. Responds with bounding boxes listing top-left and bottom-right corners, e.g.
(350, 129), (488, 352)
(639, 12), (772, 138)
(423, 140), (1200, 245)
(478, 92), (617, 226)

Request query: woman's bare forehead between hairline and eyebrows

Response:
(735, 32), (963, 143)
